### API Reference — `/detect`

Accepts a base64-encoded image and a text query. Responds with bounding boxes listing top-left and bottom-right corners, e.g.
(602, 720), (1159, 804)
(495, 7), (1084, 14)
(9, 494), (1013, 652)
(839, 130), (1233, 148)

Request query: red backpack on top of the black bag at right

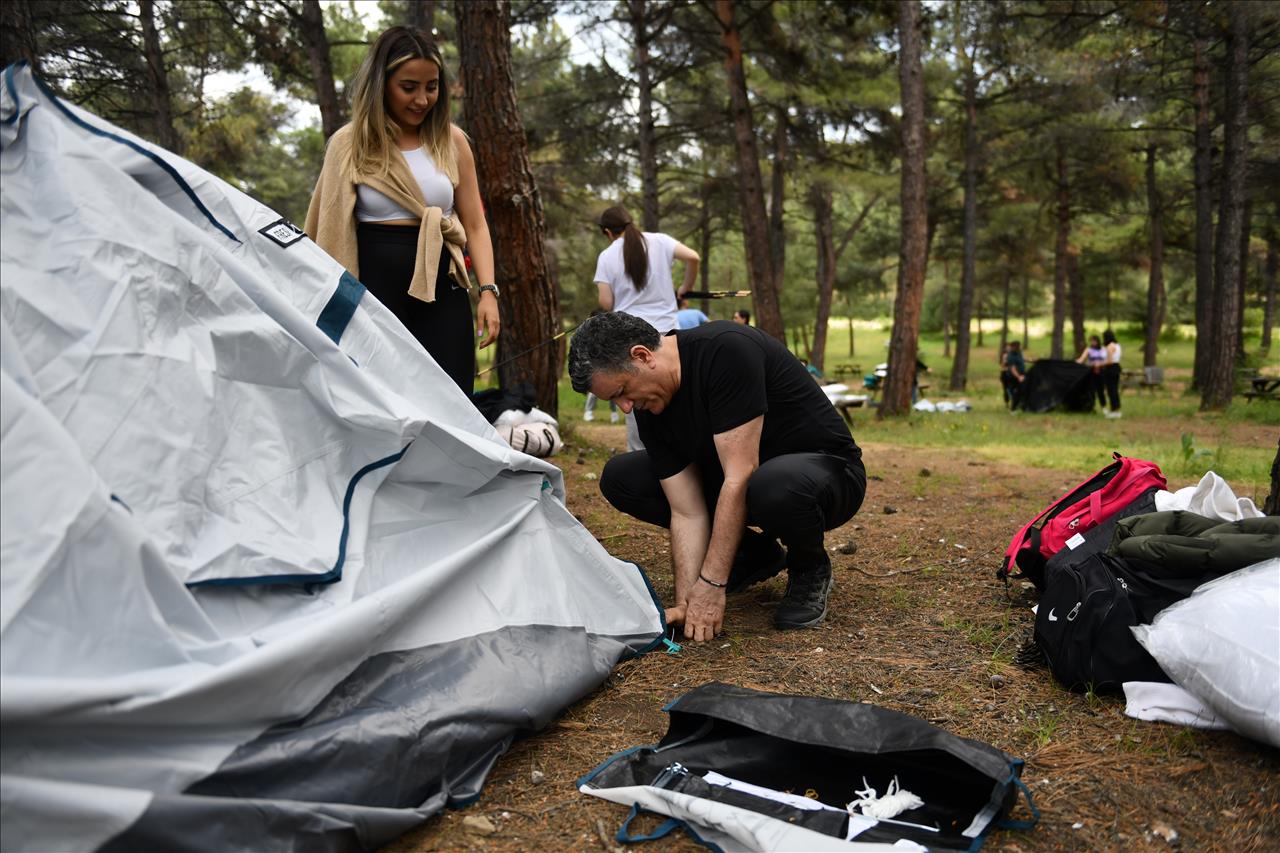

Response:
(996, 453), (1166, 589)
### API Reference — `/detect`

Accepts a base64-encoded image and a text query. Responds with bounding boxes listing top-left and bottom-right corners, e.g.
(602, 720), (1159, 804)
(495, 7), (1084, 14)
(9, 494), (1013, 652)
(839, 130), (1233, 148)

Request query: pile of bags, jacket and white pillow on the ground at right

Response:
(997, 453), (1280, 745)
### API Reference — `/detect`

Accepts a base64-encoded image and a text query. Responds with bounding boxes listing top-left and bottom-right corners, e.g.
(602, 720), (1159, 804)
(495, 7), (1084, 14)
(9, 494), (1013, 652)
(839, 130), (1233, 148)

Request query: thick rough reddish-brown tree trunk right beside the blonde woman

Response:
(454, 0), (564, 416)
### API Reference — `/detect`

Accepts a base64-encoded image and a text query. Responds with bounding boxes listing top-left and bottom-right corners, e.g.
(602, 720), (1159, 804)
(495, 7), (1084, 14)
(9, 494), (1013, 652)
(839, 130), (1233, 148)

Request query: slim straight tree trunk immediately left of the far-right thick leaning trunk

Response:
(1192, 23), (1213, 388)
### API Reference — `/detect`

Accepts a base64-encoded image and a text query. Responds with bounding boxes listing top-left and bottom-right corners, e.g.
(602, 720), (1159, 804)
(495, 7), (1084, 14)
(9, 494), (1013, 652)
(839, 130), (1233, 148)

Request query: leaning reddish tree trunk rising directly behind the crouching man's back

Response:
(716, 0), (786, 343)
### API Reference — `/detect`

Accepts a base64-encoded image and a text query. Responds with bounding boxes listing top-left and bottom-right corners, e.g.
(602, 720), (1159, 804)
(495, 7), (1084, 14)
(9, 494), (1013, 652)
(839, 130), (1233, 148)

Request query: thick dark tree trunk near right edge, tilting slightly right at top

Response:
(1201, 4), (1249, 411)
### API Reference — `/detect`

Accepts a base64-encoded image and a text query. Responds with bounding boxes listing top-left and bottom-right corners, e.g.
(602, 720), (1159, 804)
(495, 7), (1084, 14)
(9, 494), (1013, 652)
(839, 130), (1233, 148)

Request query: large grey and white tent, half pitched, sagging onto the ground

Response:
(0, 64), (663, 850)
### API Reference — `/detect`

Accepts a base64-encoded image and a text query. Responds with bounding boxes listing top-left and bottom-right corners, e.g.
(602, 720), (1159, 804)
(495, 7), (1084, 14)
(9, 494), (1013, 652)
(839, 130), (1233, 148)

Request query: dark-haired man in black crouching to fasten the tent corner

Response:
(568, 313), (867, 642)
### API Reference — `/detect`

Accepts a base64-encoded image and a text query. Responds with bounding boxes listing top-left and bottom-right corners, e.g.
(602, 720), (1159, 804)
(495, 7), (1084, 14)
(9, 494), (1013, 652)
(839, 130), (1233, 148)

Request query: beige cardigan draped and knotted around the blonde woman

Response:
(305, 124), (471, 302)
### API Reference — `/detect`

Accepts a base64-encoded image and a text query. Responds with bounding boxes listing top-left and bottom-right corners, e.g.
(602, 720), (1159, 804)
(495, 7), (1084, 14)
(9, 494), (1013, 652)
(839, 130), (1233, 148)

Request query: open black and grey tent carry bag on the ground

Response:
(579, 683), (1039, 850)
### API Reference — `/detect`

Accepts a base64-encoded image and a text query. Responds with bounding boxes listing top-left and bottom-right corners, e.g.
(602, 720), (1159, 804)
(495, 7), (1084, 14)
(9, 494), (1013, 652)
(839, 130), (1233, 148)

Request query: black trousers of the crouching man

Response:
(600, 451), (867, 579)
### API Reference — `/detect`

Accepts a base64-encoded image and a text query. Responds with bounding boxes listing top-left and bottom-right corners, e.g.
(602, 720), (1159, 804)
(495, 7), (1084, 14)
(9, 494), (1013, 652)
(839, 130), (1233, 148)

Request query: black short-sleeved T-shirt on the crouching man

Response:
(636, 320), (861, 479)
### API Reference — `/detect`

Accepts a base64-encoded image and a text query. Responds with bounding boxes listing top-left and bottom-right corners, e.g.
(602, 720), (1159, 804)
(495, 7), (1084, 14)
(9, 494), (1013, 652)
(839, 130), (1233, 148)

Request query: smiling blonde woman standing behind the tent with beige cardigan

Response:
(306, 27), (499, 394)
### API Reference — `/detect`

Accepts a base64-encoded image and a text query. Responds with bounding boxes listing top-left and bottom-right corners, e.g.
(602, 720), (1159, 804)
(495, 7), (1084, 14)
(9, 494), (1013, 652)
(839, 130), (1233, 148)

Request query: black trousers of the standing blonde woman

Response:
(356, 222), (476, 397)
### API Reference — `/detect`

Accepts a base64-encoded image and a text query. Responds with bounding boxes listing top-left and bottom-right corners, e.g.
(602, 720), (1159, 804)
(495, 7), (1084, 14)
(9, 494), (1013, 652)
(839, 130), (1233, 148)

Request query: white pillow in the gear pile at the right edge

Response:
(1132, 558), (1280, 747)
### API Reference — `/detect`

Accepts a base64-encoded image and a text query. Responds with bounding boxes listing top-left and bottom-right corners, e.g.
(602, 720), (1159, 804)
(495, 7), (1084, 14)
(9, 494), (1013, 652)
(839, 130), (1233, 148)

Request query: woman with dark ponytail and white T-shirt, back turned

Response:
(595, 206), (701, 451)
